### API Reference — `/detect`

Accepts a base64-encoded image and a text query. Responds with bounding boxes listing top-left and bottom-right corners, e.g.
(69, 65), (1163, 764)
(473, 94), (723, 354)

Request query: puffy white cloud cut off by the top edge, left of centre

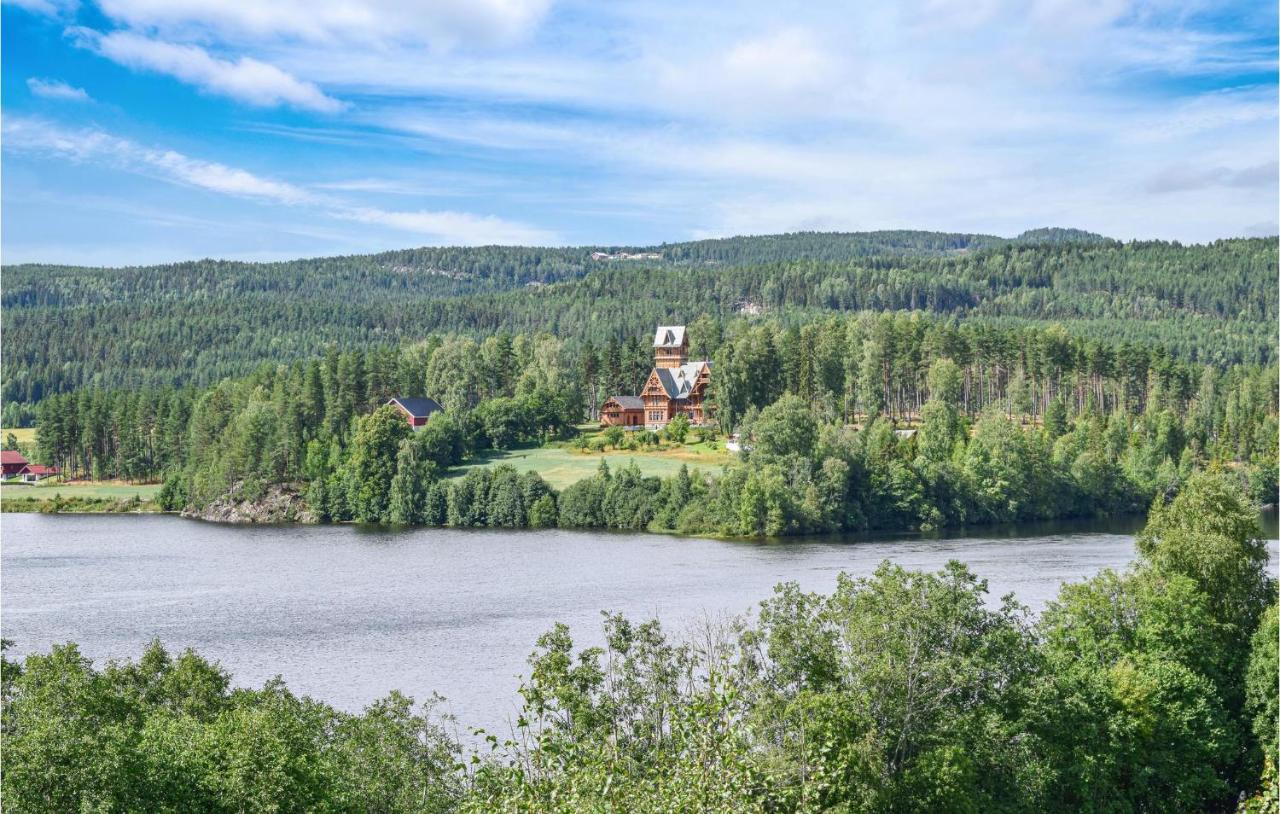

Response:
(90, 0), (550, 49)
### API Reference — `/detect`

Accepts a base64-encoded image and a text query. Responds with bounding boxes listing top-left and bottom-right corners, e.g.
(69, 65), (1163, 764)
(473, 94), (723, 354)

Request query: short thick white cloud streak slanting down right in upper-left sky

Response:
(69, 28), (344, 113)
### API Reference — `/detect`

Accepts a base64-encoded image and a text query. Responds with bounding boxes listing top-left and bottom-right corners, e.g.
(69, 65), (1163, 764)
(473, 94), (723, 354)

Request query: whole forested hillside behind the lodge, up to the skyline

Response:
(3, 229), (1277, 403)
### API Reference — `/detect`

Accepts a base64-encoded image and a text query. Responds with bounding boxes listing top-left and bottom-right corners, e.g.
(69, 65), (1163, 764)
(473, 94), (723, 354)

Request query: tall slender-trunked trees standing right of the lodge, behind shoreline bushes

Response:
(711, 314), (1275, 427)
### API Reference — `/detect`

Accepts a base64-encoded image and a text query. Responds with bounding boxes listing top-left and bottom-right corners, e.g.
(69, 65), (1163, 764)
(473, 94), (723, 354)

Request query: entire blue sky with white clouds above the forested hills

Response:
(0, 0), (1277, 265)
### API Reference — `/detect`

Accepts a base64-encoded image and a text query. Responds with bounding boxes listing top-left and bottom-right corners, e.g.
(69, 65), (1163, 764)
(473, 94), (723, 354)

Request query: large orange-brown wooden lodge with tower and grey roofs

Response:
(600, 325), (712, 430)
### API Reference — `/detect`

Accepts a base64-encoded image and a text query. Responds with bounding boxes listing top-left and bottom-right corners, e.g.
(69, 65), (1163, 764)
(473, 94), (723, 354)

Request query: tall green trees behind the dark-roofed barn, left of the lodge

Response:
(36, 334), (584, 491)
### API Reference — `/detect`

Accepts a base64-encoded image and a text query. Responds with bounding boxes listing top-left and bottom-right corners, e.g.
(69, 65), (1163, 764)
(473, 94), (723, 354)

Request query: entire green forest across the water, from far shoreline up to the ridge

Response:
(4, 230), (1277, 536)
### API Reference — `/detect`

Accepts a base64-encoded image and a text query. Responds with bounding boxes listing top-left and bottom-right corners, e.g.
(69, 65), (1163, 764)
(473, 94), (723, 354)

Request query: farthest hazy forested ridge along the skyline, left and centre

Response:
(4, 232), (1013, 308)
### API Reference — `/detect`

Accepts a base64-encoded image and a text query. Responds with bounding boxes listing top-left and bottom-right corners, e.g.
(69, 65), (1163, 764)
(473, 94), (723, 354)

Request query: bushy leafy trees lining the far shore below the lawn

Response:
(335, 383), (1277, 536)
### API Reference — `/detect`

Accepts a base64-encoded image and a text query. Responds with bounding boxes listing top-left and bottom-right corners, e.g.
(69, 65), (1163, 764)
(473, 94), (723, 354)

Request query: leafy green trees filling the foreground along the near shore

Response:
(0, 475), (1280, 814)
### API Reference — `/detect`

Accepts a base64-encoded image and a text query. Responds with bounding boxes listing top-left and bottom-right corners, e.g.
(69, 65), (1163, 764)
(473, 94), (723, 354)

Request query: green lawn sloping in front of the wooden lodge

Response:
(449, 444), (733, 489)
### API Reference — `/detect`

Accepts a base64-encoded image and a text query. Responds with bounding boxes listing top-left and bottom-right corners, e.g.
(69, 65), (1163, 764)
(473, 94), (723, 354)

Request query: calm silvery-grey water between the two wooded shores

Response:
(0, 515), (1276, 728)
